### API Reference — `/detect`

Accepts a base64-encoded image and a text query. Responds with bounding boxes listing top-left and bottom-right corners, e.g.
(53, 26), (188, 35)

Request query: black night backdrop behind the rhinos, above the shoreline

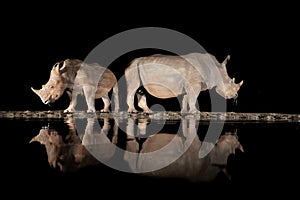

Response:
(0, 3), (300, 113)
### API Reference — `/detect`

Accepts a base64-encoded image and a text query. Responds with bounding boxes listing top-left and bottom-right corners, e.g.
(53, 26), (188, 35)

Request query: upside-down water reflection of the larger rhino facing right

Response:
(124, 119), (244, 182)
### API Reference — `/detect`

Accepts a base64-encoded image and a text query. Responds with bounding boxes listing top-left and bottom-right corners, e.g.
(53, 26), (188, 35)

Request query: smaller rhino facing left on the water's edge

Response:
(31, 59), (119, 113)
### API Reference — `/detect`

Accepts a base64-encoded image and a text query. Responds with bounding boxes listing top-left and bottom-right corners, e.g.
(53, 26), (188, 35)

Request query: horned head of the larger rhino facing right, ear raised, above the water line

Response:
(216, 55), (243, 99)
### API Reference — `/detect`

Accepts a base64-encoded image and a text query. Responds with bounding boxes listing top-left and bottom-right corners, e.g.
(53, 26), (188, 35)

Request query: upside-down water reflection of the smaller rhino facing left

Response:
(30, 117), (116, 172)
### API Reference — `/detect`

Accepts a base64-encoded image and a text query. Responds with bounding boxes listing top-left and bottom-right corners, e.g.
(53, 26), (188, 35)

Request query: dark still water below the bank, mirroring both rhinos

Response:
(0, 118), (300, 199)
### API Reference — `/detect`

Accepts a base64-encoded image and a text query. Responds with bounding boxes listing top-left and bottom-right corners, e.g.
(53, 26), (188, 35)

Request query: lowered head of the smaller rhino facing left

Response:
(31, 62), (66, 104)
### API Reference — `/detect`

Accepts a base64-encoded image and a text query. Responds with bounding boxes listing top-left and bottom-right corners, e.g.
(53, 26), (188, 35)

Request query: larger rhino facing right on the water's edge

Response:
(125, 53), (243, 113)
